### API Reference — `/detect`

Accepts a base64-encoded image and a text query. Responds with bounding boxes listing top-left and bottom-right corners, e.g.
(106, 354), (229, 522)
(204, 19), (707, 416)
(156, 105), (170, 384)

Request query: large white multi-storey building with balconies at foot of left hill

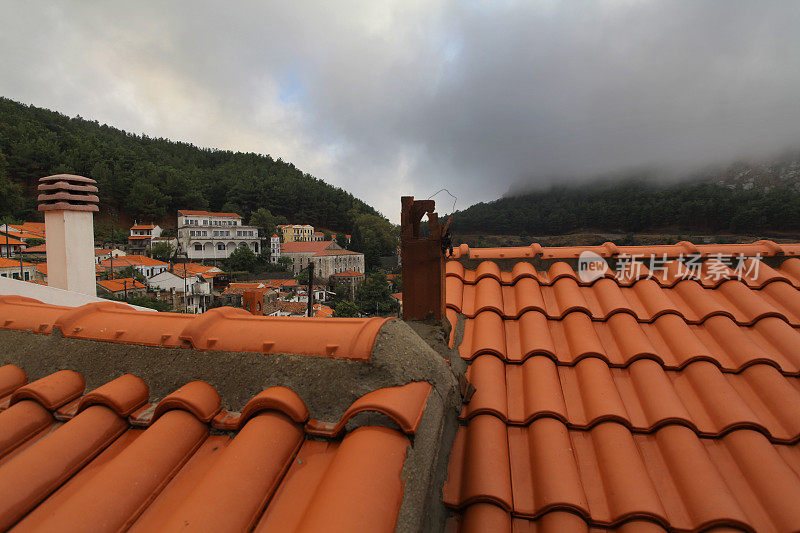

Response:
(178, 210), (261, 260)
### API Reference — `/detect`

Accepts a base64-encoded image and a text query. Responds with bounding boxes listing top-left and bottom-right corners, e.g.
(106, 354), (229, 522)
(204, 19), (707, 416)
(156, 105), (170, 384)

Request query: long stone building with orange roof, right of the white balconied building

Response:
(281, 241), (364, 281)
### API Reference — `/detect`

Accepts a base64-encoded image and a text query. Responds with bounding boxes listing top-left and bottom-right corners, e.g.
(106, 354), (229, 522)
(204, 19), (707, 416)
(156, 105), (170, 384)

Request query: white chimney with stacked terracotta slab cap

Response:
(38, 174), (99, 296)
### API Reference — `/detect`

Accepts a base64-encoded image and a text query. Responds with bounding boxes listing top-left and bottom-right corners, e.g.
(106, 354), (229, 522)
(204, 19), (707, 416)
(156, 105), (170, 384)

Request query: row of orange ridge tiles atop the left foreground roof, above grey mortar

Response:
(0, 295), (389, 360)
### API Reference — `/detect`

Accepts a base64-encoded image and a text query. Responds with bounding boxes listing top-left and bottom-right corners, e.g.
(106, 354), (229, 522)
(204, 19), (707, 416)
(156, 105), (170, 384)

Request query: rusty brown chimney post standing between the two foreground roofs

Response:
(400, 196), (445, 320)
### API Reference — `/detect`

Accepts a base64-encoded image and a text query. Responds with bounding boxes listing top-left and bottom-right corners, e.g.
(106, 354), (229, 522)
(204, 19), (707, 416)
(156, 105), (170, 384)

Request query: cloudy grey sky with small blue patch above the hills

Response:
(0, 0), (800, 221)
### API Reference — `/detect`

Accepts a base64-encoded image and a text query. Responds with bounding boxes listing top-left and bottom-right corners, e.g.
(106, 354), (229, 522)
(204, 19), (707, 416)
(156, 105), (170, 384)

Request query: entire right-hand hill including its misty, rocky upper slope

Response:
(453, 151), (800, 235)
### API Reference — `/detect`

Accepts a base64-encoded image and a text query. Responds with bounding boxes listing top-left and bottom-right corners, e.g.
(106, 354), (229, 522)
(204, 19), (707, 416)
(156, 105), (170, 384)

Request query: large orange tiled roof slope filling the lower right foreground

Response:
(443, 250), (800, 531)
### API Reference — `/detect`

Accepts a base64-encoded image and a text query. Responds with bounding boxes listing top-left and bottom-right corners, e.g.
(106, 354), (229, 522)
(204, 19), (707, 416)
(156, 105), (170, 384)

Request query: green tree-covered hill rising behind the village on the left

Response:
(0, 98), (377, 231)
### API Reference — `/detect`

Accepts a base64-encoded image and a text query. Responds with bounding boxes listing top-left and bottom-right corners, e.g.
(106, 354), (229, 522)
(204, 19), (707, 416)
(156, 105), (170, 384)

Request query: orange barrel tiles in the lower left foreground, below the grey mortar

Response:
(0, 365), (431, 531)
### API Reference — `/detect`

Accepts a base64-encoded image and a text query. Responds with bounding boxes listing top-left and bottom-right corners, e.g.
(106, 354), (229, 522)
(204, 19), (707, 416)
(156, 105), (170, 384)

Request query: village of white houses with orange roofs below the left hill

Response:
(0, 210), (402, 318)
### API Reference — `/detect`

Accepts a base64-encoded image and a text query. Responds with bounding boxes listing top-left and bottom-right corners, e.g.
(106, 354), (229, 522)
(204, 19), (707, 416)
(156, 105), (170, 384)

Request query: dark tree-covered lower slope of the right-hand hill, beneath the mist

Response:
(453, 179), (800, 235)
